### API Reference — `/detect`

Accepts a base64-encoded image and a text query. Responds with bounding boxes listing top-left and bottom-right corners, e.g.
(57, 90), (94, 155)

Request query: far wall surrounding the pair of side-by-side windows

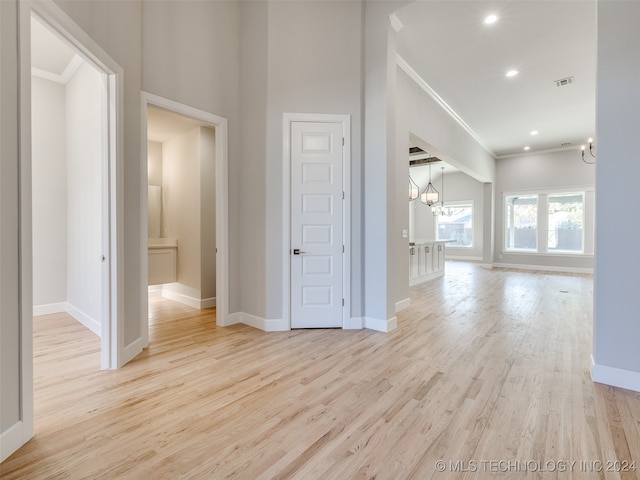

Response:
(495, 150), (595, 271)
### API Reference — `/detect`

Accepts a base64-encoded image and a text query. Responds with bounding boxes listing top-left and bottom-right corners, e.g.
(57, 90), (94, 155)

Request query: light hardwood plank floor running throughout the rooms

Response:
(0, 262), (640, 480)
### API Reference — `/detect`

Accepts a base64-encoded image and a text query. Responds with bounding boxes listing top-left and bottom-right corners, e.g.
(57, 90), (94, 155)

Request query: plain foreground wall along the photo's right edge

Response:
(593, 1), (640, 391)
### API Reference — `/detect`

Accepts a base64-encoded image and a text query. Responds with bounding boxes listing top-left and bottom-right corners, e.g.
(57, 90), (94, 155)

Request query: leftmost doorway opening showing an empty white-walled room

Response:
(29, 9), (118, 369)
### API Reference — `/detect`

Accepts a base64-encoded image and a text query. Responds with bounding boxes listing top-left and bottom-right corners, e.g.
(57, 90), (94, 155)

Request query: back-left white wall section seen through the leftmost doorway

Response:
(31, 77), (67, 306)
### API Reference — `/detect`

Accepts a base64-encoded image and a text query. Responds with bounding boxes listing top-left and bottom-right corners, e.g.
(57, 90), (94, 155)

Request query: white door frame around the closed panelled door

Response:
(282, 113), (352, 329)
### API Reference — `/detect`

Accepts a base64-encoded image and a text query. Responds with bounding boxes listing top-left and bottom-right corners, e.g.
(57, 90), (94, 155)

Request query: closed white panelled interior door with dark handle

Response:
(291, 122), (344, 328)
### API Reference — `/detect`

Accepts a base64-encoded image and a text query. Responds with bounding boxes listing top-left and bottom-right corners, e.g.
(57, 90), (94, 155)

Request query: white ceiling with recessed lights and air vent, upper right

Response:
(396, 0), (596, 158)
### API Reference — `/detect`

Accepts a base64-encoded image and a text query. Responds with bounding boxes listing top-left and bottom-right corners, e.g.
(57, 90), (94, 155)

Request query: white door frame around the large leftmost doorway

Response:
(19, 1), (124, 375)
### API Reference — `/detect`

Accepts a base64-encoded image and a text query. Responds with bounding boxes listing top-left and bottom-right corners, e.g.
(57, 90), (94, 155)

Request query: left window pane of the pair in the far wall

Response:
(505, 195), (538, 251)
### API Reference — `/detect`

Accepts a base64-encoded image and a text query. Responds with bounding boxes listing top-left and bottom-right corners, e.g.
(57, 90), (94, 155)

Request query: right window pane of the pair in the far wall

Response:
(547, 193), (584, 253)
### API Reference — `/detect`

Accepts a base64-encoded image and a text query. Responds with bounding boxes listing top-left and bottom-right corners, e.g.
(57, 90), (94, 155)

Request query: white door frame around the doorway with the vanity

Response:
(140, 91), (231, 342)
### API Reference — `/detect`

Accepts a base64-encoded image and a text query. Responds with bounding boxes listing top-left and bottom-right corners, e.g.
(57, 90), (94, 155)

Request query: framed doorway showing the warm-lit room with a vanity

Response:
(141, 93), (228, 346)
